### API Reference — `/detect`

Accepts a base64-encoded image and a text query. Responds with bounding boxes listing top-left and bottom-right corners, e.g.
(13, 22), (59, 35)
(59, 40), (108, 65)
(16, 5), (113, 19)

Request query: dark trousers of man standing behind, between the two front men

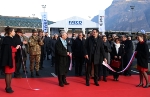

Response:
(75, 57), (84, 75)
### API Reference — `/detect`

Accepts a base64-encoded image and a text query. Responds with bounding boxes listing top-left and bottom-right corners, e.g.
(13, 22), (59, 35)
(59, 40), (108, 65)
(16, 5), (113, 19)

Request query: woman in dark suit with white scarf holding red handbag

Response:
(111, 38), (124, 81)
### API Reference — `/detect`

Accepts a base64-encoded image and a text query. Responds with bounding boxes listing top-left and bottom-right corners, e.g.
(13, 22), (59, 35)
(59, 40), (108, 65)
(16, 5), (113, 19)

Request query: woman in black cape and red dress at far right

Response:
(135, 34), (150, 88)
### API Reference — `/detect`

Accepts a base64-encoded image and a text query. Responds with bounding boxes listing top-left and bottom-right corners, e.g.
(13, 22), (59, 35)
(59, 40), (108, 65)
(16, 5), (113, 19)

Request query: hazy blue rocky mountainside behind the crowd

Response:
(92, 0), (150, 32)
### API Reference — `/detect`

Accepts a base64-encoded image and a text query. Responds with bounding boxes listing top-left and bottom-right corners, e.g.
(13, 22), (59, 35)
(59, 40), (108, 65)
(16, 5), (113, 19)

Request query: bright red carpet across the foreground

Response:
(0, 75), (150, 97)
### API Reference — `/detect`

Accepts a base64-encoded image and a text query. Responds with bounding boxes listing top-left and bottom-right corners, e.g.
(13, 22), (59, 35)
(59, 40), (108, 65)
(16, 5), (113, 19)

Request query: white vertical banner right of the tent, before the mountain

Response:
(98, 10), (105, 35)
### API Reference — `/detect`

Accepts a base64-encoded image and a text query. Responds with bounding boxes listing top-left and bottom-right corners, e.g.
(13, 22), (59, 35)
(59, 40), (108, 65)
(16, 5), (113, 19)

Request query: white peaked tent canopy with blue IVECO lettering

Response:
(48, 16), (98, 34)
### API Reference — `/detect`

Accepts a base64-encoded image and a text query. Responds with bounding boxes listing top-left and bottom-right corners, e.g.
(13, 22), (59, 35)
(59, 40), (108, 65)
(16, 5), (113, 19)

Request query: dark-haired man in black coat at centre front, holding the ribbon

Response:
(84, 29), (107, 86)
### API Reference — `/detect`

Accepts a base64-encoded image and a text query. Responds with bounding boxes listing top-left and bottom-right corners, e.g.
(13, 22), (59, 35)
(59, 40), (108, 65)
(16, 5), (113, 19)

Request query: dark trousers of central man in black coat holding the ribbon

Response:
(86, 63), (98, 83)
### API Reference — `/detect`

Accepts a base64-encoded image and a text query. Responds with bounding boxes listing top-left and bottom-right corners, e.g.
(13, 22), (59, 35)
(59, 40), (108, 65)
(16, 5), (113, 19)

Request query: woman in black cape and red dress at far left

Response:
(0, 27), (20, 93)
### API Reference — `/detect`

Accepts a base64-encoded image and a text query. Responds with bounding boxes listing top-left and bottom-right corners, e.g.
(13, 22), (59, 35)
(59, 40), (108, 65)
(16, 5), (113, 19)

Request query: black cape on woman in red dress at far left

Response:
(0, 36), (17, 68)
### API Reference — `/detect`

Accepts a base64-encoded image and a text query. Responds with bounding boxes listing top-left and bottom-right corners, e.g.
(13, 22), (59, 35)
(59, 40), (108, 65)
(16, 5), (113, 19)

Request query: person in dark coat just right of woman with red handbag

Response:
(122, 35), (133, 76)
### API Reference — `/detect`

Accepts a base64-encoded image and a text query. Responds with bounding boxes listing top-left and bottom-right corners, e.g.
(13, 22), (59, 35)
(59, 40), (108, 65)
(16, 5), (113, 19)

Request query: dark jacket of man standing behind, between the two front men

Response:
(72, 38), (85, 57)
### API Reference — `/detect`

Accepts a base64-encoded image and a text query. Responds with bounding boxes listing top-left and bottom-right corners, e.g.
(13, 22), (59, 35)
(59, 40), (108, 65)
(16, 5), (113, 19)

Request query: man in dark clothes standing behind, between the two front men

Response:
(72, 33), (85, 76)
